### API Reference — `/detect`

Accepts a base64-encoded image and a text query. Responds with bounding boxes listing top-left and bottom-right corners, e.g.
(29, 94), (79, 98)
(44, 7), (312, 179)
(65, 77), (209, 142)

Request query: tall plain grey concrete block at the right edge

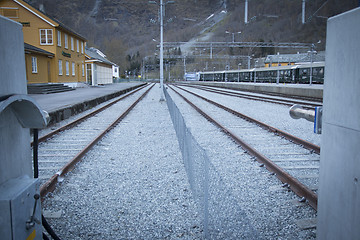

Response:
(317, 8), (360, 240)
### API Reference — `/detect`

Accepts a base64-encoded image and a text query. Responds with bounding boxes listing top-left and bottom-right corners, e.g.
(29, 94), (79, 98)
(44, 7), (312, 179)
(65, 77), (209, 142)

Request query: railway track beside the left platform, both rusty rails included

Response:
(37, 85), (154, 197)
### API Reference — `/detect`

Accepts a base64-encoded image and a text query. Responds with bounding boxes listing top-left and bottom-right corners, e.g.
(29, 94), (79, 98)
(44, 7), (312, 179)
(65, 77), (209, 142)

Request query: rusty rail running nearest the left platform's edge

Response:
(31, 84), (148, 146)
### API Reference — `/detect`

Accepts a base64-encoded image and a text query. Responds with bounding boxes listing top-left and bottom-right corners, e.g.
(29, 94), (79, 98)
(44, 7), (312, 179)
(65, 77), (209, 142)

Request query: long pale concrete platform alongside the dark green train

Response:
(184, 82), (323, 99)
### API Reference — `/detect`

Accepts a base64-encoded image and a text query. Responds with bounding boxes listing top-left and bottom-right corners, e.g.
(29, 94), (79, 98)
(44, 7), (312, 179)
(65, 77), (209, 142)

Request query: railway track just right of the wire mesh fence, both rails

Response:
(170, 86), (320, 209)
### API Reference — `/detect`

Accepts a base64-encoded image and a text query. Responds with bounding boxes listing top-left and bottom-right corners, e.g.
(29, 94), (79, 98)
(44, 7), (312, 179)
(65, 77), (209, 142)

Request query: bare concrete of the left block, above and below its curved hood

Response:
(0, 16), (32, 185)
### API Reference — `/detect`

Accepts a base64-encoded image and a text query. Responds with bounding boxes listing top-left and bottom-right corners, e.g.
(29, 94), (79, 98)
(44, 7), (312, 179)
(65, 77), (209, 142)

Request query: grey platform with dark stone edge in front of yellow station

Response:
(29, 82), (145, 125)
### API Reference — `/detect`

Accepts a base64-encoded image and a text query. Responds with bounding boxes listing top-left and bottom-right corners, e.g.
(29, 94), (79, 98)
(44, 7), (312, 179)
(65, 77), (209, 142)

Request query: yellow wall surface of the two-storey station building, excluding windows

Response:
(0, 0), (85, 83)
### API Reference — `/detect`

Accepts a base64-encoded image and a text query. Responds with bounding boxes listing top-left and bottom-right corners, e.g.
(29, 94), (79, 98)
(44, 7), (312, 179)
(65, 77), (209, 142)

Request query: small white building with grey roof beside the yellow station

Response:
(85, 47), (119, 86)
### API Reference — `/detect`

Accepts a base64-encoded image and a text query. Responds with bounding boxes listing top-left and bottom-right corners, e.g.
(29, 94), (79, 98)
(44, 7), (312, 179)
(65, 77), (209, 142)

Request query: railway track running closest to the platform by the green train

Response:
(177, 84), (322, 109)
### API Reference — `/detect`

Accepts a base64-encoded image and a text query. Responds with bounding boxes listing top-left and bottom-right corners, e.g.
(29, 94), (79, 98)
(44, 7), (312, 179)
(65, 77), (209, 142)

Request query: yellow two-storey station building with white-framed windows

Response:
(0, 0), (86, 84)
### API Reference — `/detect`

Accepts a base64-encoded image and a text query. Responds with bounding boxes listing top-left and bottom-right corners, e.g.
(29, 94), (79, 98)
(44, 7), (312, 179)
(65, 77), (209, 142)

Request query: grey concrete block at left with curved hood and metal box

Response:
(0, 16), (47, 240)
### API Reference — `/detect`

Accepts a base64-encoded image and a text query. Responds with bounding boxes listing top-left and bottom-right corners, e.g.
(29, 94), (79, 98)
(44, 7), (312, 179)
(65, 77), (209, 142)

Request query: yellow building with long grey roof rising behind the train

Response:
(265, 52), (325, 67)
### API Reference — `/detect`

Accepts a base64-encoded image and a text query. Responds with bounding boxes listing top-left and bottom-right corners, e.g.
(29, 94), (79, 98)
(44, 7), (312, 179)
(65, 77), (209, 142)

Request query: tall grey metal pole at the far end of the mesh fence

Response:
(149, 0), (174, 101)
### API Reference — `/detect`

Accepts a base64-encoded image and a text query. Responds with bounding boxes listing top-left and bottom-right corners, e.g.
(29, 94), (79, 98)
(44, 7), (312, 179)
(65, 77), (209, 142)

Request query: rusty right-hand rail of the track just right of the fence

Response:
(173, 86), (320, 154)
